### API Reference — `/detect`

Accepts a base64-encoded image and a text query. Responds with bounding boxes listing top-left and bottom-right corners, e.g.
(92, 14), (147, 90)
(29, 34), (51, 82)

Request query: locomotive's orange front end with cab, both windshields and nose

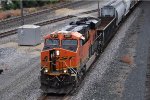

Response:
(41, 31), (85, 87)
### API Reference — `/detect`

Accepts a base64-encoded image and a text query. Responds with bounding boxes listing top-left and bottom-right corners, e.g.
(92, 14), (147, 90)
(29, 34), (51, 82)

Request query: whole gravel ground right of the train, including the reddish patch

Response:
(72, 2), (150, 100)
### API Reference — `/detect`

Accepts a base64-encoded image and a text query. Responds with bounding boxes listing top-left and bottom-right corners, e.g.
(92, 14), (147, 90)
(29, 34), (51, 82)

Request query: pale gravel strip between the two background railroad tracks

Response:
(0, 0), (109, 33)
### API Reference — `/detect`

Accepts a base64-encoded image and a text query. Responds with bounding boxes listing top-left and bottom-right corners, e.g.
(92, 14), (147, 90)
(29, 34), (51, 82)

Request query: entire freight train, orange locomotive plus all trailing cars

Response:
(40, 0), (138, 93)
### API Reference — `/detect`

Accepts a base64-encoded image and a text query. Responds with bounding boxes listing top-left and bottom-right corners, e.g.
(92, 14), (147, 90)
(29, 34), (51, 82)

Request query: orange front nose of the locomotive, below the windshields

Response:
(41, 48), (78, 75)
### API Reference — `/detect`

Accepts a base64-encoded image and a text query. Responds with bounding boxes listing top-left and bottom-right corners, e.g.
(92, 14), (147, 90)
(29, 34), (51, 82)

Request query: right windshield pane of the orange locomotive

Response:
(62, 40), (78, 52)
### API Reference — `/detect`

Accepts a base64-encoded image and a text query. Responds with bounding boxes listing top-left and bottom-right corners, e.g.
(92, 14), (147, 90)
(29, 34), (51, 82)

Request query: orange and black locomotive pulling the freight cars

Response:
(41, 17), (101, 93)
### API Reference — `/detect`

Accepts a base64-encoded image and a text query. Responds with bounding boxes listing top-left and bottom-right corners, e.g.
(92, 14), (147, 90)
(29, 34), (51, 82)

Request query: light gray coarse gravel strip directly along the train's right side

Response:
(72, 2), (143, 100)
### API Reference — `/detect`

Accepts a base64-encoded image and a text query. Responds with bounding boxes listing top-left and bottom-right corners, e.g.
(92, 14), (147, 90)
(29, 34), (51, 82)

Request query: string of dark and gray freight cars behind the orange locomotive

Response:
(97, 0), (138, 48)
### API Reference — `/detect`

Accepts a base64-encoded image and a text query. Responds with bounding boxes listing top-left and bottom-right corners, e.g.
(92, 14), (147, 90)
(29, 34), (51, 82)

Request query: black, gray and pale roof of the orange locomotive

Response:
(44, 17), (101, 39)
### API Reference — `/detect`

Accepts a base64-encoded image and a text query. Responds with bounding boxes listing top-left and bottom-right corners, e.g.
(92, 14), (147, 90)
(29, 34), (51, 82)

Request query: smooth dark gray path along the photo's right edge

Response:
(123, 2), (150, 100)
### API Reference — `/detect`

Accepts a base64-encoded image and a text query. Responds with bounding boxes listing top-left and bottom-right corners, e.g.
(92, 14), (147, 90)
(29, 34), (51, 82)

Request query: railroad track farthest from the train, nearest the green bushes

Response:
(0, 1), (89, 31)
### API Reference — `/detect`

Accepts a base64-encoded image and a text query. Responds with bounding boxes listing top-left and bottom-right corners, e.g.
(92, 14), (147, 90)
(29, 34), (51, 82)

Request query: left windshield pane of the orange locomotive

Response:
(44, 39), (59, 49)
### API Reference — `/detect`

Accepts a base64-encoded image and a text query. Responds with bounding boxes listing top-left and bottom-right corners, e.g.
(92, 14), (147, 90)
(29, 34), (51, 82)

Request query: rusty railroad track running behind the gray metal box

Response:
(0, 9), (97, 38)
